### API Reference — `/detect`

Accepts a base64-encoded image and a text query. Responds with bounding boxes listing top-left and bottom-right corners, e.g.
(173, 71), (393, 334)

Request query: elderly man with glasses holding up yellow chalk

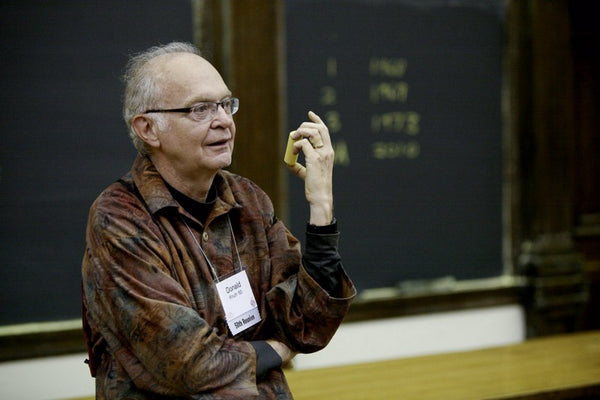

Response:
(82, 43), (356, 399)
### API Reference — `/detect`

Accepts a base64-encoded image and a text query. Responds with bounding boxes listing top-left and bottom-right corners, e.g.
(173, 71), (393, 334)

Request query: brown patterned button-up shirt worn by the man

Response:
(82, 156), (356, 400)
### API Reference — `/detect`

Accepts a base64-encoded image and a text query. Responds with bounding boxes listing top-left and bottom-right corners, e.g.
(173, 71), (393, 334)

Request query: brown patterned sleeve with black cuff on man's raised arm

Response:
(265, 216), (356, 353)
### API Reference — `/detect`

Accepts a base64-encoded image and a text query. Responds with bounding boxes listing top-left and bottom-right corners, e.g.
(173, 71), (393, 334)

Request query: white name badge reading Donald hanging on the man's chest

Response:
(216, 270), (261, 335)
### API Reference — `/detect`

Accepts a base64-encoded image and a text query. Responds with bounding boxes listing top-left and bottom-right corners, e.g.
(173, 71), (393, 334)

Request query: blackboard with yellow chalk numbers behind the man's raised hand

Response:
(285, 0), (504, 289)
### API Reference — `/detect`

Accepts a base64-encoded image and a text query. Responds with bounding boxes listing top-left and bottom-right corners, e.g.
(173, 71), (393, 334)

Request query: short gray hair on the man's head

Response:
(123, 42), (200, 155)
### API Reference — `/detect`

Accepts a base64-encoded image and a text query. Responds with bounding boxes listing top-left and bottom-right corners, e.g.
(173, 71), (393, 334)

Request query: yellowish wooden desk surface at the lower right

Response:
(286, 331), (600, 400)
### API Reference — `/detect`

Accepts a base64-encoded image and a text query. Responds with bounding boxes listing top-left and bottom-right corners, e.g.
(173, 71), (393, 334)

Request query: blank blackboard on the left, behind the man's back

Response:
(0, 0), (193, 325)
